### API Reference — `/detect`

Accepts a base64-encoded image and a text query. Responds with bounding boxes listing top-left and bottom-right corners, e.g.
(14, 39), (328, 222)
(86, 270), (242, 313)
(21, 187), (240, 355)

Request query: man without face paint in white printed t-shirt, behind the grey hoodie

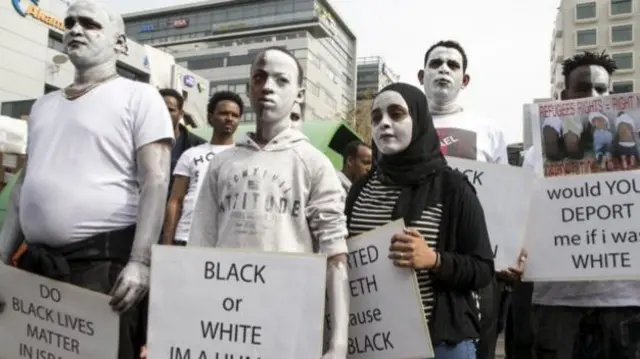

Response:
(163, 91), (244, 246)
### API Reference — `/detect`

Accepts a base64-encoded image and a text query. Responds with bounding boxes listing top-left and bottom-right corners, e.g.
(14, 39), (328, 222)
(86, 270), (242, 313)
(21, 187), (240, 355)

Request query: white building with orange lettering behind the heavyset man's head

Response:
(0, 0), (209, 123)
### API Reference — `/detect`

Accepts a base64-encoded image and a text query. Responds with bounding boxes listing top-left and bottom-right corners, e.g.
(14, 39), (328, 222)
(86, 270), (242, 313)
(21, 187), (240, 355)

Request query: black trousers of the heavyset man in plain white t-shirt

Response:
(18, 227), (144, 359)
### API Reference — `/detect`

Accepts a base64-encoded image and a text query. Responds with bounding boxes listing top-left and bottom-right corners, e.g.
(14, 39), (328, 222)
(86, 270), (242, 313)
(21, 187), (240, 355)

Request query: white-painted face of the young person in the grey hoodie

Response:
(251, 50), (304, 123)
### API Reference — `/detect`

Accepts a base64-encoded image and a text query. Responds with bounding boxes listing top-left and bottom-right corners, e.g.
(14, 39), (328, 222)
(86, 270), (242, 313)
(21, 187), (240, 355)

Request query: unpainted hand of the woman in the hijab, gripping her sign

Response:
(389, 228), (438, 269)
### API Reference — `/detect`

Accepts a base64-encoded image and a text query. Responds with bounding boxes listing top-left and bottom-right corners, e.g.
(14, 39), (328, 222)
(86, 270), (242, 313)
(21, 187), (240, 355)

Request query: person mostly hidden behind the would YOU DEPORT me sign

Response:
(523, 52), (640, 359)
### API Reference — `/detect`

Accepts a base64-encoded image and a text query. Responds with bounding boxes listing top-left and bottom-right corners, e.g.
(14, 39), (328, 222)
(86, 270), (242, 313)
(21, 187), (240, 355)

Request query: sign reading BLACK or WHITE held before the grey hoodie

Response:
(147, 245), (327, 359)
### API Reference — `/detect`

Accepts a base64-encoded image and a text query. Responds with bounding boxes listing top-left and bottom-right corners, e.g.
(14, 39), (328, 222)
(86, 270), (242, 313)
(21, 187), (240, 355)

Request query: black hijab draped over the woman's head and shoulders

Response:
(346, 83), (462, 225)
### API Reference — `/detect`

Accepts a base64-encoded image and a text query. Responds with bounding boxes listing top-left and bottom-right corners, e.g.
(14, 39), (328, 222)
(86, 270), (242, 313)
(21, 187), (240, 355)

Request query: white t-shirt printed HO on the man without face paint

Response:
(173, 143), (233, 241)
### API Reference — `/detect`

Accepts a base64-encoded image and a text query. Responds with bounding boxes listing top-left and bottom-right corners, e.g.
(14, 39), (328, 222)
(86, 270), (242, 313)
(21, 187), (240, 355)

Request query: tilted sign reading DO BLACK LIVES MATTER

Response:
(0, 264), (120, 359)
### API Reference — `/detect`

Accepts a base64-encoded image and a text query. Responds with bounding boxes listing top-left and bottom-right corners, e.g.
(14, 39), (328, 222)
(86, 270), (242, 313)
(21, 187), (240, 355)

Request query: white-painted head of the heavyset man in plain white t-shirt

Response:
(63, 0), (126, 68)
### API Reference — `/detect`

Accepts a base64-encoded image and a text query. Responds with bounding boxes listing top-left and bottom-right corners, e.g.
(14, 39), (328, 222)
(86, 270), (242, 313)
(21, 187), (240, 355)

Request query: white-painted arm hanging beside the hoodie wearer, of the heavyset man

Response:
(111, 140), (171, 313)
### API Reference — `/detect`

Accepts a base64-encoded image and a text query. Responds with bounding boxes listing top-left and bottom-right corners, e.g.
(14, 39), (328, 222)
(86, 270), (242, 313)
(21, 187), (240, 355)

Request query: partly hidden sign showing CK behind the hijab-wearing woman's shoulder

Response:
(447, 157), (534, 270)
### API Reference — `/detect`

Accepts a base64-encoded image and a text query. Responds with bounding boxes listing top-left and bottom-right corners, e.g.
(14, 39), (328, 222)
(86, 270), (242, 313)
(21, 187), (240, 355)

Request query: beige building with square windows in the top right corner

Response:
(550, 0), (640, 99)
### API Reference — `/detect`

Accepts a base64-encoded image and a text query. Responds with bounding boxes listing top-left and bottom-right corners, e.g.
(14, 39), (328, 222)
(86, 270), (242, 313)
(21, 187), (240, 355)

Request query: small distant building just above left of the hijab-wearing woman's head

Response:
(357, 56), (400, 100)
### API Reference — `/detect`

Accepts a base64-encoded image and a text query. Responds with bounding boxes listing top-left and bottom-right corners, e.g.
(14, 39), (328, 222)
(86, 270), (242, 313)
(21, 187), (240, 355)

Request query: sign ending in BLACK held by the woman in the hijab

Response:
(325, 219), (434, 359)
